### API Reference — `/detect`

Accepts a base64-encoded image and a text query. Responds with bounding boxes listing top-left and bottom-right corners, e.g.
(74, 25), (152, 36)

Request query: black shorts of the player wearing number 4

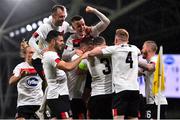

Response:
(113, 90), (140, 117)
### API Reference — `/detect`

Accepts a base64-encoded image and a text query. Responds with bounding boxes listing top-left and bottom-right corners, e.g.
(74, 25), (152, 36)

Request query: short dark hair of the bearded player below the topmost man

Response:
(46, 30), (63, 43)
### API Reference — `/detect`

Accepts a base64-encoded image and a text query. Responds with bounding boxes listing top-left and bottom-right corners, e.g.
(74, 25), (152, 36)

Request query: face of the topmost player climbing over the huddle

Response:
(53, 8), (65, 26)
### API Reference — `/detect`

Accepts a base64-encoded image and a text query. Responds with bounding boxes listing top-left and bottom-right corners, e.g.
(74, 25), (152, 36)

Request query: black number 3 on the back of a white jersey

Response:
(100, 58), (111, 75)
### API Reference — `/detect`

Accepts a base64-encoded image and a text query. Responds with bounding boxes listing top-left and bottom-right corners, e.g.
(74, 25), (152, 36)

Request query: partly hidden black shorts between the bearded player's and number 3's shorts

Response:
(71, 98), (87, 119)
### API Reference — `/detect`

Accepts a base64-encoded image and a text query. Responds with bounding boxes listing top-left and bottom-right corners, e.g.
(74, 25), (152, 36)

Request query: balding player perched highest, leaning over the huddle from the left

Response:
(29, 5), (71, 80)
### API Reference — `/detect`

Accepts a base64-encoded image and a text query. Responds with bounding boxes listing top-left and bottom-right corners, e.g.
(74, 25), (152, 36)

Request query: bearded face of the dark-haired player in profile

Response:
(54, 36), (64, 50)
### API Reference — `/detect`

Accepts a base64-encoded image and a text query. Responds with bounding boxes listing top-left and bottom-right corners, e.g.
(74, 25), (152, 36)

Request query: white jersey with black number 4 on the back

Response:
(102, 44), (140, 93)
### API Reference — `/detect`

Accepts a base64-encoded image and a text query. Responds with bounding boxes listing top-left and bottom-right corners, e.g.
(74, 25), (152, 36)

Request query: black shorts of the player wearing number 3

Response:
(88, 94), (112, 119)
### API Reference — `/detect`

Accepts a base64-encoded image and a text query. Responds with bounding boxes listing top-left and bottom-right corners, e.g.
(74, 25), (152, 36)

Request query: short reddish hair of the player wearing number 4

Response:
(116, 29), (129, 40)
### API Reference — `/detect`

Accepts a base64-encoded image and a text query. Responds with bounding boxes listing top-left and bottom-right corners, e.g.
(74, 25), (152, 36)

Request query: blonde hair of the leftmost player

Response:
(20, 39), (30, 58)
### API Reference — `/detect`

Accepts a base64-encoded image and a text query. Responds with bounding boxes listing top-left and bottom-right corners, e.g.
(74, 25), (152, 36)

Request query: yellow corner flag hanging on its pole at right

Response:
(152, 46), (165, 95)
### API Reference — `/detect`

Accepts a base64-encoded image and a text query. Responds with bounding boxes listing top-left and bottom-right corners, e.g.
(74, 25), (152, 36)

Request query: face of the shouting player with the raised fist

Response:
(72, 19), (86, 36)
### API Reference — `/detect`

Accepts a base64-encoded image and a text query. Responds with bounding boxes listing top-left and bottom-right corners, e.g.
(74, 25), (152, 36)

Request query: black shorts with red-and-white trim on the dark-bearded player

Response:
(47, 95), (71, 119)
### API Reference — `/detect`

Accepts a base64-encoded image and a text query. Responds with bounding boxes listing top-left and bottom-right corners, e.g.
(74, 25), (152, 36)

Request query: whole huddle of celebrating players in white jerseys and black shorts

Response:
(9, 5), (167, 119)
